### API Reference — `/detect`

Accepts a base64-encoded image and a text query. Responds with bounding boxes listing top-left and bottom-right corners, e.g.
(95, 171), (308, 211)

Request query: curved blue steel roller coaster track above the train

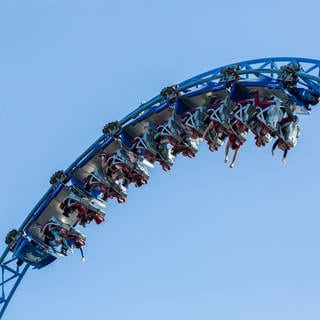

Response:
(0, 57), (320, 318)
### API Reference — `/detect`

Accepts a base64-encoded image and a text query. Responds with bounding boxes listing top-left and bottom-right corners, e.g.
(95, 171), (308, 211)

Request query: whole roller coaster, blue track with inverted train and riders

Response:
(0, 57), (320, 318)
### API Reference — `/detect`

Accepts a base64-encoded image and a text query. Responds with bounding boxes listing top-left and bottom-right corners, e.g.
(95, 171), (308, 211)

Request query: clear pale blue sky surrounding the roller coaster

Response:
(0, 0), (320, 320)
